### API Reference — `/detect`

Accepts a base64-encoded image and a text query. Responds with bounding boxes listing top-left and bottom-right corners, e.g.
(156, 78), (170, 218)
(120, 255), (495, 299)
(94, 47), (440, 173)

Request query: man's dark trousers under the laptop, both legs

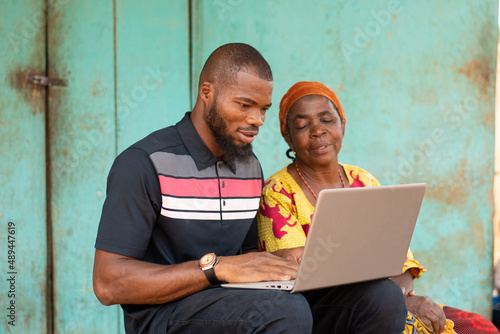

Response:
(150, 279), (406, 334)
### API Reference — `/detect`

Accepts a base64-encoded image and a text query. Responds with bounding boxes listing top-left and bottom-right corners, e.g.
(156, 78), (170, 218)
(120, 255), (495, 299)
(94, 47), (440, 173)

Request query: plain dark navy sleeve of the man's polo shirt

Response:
(95, 148), (161, 258)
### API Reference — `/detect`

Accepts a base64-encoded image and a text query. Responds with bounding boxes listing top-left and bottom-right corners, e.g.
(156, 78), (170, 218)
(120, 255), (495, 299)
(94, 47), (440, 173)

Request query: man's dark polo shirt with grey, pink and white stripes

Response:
(96, 113), (263, 264)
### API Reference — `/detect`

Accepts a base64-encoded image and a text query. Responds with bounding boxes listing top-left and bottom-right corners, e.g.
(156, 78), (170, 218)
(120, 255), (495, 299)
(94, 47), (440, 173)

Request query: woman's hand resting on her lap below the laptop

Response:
(406, 290), (446, 333)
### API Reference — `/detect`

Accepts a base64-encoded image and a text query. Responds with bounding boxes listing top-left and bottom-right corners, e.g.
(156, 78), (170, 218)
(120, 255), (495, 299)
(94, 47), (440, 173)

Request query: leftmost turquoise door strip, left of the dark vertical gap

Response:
(0, 0), (47, 333)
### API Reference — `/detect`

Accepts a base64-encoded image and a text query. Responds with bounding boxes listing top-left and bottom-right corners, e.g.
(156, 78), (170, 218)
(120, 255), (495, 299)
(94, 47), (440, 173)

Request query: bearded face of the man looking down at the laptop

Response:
(205, 71), (273, 162)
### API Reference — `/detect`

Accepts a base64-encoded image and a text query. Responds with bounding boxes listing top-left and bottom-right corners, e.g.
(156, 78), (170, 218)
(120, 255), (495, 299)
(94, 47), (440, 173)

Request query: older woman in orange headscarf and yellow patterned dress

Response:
(257, 82), (498, 333)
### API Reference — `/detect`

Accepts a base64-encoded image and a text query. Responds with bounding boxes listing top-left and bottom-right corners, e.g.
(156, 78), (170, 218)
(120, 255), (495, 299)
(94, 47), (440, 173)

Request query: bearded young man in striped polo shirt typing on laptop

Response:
(94, 43), (406, 333)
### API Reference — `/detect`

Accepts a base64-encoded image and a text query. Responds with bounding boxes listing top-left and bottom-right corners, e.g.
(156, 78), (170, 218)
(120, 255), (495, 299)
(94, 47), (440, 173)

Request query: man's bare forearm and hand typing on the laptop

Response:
(93, 249), (298, 305)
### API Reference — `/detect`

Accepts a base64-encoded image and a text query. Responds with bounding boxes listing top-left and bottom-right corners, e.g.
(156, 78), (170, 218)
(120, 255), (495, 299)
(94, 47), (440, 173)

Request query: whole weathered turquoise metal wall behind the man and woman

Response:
(0, 0), (498, 333)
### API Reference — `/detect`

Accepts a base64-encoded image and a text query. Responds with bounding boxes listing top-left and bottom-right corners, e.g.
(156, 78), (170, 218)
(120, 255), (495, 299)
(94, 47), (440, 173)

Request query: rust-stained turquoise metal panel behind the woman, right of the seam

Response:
(192, 0), (498, 316)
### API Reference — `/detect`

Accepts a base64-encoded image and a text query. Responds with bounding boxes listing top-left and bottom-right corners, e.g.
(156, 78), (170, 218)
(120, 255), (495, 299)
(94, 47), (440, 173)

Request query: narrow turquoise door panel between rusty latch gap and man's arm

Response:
(48, 0), (119, 333)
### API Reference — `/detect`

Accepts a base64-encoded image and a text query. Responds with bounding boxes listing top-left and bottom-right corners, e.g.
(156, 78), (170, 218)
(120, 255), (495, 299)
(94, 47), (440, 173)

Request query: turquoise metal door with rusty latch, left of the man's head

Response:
(0, 0), (190, 333)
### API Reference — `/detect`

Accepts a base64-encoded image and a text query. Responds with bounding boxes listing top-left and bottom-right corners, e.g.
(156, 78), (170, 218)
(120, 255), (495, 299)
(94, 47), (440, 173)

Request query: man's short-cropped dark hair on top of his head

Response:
(199, 43), (273, 86)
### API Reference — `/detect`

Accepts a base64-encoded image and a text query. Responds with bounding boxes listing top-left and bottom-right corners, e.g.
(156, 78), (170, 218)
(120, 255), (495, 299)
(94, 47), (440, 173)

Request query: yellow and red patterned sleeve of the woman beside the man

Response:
(257, 180), (306, 252)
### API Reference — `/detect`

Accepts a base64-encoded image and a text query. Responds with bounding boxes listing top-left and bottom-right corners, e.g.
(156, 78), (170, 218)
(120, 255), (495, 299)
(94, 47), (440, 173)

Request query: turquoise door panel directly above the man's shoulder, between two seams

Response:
(116, 0), (191, 153)
